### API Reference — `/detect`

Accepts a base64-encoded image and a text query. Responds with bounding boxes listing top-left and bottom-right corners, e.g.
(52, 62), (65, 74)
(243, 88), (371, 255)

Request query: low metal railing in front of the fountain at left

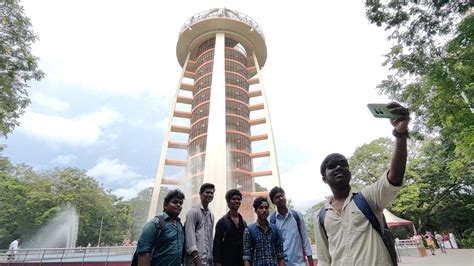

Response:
(0, 246), (136, 265)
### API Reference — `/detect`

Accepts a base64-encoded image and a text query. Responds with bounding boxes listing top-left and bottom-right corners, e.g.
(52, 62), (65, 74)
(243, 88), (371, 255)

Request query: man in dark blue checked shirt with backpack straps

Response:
(243, 197), (285, 266)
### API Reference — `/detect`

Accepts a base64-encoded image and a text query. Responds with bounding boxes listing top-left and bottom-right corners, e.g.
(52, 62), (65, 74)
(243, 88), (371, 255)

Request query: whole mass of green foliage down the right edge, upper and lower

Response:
(365, 0), (474, 244)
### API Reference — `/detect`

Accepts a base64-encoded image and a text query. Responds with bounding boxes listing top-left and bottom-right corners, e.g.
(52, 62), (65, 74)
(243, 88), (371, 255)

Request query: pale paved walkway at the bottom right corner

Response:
(399, 249), (474, 266)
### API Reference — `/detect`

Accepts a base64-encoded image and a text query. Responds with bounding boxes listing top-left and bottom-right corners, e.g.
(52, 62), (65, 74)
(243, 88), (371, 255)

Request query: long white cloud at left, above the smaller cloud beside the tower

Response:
(18, 108), (120, 147)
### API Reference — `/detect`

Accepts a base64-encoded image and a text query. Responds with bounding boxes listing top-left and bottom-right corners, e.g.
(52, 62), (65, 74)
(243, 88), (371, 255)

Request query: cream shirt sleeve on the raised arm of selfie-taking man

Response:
(361, 171), (404, 212)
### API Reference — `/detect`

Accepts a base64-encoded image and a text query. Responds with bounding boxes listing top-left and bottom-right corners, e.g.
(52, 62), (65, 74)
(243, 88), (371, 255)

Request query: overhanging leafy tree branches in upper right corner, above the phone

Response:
(366, 0), (474, 169)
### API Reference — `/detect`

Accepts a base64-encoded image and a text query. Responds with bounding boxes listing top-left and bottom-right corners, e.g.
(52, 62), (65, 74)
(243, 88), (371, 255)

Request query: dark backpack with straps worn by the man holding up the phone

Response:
(318, 193), (398, 266)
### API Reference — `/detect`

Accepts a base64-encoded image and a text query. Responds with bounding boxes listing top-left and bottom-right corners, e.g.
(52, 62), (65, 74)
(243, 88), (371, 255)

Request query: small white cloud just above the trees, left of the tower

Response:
(87, 158), (154, 199)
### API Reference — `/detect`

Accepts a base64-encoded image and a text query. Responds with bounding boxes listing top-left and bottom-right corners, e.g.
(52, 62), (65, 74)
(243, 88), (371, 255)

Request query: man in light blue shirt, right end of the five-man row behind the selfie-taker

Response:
(268, 187), (313, 266)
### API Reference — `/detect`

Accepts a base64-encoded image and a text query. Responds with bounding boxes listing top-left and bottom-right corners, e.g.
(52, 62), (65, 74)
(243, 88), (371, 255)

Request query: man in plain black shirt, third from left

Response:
(213, 189), (247, 266)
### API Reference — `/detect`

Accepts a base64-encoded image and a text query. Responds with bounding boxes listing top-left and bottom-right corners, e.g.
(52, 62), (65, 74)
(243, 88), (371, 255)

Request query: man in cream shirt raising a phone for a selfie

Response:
(316, 103), (410, 266)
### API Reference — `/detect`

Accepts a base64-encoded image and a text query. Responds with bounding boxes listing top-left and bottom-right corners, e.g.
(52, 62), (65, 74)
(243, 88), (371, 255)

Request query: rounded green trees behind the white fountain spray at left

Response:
(0, 165), (132, 248)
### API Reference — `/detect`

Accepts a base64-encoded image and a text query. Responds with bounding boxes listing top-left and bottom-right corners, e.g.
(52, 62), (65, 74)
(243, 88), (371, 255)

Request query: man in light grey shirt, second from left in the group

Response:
(184, 183), (215, 266)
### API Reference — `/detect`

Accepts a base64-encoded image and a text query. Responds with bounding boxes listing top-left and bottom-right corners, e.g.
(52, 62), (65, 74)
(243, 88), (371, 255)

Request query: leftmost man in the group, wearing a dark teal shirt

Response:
(137, 189), (184, 266)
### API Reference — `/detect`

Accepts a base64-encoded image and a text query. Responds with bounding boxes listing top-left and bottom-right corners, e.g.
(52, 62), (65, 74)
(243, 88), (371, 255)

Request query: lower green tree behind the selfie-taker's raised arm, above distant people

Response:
(391, 139), (474, 236)
